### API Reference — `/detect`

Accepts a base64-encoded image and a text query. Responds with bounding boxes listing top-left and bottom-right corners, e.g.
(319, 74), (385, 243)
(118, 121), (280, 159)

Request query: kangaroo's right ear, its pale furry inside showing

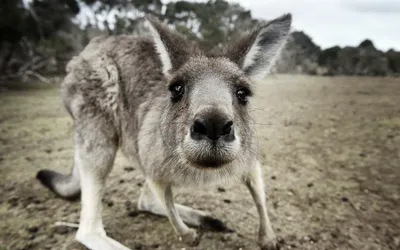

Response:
(225, 14), (292, 78)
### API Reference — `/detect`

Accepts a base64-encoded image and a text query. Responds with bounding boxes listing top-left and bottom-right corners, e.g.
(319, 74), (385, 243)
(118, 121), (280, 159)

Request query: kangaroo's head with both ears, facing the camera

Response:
(148, 14), (291, 169)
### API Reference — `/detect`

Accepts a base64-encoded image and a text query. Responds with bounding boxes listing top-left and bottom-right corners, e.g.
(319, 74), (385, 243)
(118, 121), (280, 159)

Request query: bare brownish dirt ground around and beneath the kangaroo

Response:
(0, 76), (400, 250)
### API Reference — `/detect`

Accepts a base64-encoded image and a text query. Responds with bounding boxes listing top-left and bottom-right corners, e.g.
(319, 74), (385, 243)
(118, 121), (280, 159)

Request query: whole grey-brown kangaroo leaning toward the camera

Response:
(37, 14), (292, 250)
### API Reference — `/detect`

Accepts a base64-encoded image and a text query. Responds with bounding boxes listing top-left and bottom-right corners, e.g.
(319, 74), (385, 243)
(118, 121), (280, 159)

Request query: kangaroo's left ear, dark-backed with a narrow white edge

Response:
(146, 16), (197, 75)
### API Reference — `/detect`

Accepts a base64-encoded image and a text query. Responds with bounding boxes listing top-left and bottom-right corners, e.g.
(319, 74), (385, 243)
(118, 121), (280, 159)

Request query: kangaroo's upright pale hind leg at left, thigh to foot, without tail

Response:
(75, 119), (128, 250)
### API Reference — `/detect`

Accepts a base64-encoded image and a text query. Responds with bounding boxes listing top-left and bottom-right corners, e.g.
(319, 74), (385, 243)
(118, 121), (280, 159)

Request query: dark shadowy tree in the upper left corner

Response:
(0, 0), (87, 80)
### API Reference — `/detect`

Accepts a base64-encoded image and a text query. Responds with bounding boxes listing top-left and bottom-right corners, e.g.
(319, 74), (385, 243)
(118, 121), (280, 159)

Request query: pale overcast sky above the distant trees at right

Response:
(167, 0), (400, 50)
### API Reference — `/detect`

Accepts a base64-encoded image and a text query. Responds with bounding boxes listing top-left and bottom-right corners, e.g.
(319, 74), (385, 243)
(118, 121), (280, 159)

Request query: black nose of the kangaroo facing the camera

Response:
(190, 117), (235, 141)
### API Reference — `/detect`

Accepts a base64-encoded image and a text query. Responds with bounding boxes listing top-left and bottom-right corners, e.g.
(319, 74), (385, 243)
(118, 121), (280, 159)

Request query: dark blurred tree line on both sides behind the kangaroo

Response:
(0, 0), (400, 83)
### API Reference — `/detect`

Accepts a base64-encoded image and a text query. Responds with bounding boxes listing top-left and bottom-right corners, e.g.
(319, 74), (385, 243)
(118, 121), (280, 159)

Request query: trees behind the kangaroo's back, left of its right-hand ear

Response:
(0, 0), (257, 84)
